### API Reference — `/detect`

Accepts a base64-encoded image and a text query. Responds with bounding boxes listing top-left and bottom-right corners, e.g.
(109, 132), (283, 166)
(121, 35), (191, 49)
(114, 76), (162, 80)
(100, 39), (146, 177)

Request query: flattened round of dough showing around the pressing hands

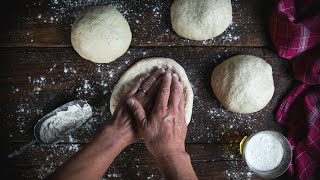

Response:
(110, 57), (193, 124)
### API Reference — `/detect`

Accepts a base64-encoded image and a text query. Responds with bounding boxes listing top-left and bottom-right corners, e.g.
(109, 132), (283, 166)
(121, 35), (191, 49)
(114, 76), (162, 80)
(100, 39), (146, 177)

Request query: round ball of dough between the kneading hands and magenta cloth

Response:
(211, 55), (274, 114)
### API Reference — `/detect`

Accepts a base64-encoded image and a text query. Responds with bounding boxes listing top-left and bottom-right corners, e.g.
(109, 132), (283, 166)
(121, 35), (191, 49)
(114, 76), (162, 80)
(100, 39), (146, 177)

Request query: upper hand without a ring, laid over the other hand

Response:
(126, 71), (187, 159)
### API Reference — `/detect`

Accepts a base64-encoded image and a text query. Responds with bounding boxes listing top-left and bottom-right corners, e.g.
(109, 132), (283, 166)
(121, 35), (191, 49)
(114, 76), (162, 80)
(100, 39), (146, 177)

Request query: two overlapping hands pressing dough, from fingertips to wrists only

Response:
(111, 68), (187, 159)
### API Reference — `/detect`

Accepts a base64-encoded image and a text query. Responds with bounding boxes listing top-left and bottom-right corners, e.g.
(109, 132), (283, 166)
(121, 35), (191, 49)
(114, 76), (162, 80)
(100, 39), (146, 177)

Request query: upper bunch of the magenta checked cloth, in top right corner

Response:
(270, 0), (320, 59)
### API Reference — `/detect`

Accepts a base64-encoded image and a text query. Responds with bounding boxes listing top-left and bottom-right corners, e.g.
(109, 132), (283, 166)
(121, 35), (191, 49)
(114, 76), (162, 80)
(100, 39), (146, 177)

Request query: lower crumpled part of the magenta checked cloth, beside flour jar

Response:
(276, 47), (320, 180)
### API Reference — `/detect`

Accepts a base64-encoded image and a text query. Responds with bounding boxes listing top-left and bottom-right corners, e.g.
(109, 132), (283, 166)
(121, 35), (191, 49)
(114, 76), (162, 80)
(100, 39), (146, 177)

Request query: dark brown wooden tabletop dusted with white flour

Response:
(0, 0), (293, 179)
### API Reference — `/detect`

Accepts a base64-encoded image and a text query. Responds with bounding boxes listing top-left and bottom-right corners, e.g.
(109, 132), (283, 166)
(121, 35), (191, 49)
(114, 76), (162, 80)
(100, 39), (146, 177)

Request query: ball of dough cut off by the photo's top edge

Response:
(171, 0), (232, 40)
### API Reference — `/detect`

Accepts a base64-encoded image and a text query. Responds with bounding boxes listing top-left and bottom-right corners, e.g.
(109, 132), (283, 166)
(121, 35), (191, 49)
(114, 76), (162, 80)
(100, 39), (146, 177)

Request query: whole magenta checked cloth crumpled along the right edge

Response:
(270, 0), (320, 180)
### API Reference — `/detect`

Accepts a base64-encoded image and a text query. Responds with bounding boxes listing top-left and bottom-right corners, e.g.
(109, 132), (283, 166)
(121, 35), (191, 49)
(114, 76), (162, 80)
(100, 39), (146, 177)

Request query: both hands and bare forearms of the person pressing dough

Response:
(49, 68), (192, 180)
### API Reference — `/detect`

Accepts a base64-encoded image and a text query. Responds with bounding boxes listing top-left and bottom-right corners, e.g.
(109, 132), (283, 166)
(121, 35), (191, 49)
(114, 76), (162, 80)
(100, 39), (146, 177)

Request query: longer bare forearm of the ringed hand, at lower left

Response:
(50, 127), (126, 180)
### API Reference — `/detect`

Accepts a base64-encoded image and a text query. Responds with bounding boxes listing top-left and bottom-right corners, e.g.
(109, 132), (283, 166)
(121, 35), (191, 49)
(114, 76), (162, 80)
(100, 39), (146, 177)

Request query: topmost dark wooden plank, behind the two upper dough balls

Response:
(0, 0), (272, 47)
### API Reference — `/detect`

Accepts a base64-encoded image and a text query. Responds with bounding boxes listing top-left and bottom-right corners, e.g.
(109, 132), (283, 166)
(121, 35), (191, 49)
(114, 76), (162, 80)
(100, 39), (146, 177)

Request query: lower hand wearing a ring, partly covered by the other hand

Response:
(107, 68), (165, 146)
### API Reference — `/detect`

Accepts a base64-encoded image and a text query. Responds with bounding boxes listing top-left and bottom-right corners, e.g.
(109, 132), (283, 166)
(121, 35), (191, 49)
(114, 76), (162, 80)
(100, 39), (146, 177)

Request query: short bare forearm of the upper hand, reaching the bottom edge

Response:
(157, 152), (198, 179)
